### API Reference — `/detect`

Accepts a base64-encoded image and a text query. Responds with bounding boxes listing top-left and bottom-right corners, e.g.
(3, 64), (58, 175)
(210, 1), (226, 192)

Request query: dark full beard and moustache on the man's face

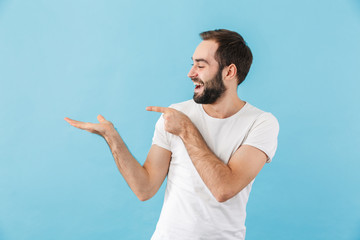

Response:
(191, 69), (226, 104)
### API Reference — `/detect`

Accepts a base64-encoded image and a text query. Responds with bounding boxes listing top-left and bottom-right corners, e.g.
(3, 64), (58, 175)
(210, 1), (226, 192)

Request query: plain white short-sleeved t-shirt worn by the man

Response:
(151, 100), (279, 240)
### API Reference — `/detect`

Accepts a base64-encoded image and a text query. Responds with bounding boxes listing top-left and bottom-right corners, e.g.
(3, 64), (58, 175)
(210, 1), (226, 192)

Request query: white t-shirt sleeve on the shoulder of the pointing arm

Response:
(243, 113), (279, 163)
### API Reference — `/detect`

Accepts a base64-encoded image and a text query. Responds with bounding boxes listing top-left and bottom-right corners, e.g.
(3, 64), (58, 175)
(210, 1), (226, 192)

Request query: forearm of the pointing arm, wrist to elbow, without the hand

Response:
(181, 125), (233, 202)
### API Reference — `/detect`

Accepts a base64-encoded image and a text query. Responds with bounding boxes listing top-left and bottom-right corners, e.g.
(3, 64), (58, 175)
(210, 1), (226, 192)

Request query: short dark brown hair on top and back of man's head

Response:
(200, 29), (253, 85)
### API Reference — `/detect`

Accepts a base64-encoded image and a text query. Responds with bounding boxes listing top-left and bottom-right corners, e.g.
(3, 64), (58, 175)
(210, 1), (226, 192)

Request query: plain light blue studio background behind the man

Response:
(0, 0), (360, 240)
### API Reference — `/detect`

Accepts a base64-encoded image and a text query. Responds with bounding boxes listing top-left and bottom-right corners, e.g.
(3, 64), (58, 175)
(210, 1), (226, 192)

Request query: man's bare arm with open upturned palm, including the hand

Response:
(65, 115), (171, 201)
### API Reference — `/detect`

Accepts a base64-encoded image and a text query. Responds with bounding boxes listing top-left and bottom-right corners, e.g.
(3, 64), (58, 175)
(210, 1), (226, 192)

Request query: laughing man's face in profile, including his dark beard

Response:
(188, 40), (226, 104)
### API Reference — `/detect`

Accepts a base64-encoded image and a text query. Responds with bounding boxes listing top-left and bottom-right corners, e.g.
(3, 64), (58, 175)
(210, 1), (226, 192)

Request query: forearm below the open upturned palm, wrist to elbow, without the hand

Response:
(104, 129), (151, 200)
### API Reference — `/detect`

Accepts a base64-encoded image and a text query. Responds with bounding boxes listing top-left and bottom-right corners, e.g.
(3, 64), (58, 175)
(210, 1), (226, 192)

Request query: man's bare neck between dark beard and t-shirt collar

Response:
(202, 92), (245, 118)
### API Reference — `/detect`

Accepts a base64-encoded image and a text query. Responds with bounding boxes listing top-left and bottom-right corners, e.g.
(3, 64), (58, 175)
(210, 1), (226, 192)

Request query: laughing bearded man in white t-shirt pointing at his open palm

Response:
(65, 29), (279, 240)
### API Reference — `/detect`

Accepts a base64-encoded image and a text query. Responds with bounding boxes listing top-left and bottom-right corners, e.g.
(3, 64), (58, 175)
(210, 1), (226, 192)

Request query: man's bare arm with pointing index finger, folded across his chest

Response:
(147, 107), (276, 202)
